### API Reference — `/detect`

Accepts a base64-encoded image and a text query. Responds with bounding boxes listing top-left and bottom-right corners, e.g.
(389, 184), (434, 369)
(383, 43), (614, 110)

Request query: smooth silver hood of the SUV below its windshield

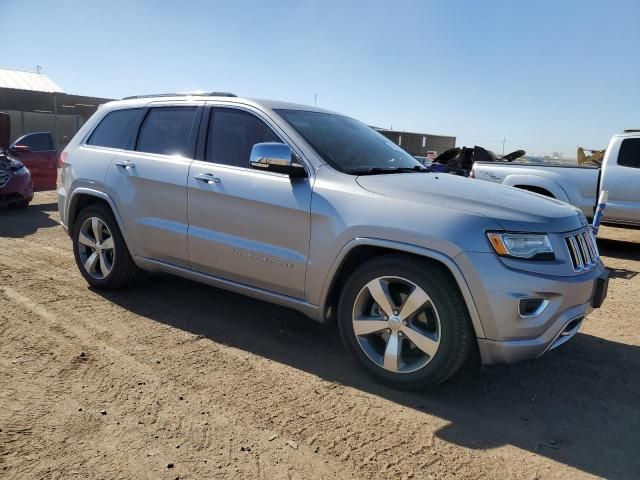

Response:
(356, 173), (586, 233)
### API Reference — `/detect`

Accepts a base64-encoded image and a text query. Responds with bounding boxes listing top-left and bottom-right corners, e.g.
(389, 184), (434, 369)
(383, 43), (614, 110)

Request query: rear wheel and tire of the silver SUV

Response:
(71, 204), (140, 290)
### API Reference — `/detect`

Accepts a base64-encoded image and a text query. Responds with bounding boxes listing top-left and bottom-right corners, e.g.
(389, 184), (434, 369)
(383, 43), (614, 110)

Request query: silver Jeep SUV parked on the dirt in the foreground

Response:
(58, 93), (607, 388)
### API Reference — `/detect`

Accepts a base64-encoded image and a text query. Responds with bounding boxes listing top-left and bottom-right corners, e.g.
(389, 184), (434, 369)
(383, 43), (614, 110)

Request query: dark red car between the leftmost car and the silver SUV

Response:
(9, 132), (58, 191)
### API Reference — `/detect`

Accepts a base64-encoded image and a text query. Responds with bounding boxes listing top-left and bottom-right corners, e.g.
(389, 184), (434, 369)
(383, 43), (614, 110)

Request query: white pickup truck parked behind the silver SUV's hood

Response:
(471, 130), (640, 225)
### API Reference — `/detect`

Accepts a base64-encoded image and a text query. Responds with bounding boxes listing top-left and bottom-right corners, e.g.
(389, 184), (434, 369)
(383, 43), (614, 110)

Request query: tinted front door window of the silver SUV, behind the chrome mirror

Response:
(206, 108), (282, 168)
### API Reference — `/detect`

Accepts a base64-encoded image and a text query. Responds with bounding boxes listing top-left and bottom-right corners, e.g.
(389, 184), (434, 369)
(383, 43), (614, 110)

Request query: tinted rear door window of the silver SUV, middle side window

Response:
(136, 107), (197, 157)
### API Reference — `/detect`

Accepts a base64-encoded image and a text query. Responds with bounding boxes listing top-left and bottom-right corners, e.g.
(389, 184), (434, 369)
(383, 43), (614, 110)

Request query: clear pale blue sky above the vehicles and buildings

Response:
(0, 0), (640, 157)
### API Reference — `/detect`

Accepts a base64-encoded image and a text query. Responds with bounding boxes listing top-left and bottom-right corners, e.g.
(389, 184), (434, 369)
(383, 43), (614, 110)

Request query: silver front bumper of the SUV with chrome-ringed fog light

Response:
(456, 252), (607, 364)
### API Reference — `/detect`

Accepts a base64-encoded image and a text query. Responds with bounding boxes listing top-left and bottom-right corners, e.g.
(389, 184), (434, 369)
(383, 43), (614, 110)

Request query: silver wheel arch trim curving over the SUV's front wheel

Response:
(320, 238), (485, 338)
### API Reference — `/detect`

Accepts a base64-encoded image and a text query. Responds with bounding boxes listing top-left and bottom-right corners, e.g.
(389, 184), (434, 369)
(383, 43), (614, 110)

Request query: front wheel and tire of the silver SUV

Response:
(338, 254), (475, 390)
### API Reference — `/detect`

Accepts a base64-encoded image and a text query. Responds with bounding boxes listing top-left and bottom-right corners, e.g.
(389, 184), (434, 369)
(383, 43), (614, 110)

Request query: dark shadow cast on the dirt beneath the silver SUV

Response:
(97, 276), (640, 478)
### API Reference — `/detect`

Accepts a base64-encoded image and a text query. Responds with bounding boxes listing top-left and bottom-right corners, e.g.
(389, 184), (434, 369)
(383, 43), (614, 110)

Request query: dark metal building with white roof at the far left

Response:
(0, 69), (110, 151)
